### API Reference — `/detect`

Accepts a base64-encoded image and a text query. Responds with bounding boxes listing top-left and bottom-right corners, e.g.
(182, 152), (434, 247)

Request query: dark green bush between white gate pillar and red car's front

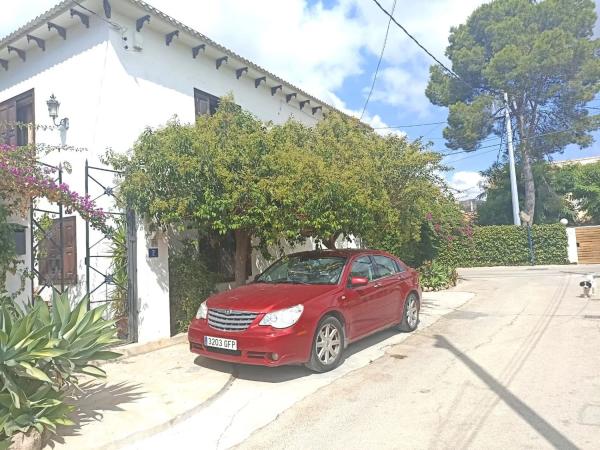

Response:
(169, 240), (217, 334)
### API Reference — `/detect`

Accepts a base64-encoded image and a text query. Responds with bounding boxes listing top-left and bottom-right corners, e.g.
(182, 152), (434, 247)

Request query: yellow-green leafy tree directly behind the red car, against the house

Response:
(108, 98), (459, 284)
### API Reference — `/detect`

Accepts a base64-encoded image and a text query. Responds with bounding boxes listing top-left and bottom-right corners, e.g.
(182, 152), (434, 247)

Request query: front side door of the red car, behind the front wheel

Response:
(344, 255), (381, 339)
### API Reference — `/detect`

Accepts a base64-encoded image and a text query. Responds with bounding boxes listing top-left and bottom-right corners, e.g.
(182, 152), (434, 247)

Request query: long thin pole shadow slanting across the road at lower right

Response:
(434, 335), (578, 450)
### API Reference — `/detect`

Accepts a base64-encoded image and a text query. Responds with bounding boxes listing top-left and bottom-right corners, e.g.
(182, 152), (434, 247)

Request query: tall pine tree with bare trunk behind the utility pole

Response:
(426, 0), (600, 224)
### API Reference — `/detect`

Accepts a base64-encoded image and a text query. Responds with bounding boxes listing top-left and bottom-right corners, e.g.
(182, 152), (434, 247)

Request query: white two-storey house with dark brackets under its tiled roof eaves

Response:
(0, 0), (344, 341)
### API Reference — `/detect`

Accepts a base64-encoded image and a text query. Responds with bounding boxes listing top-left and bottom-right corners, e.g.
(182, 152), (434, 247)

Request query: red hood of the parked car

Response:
(208, 283), (339, 312)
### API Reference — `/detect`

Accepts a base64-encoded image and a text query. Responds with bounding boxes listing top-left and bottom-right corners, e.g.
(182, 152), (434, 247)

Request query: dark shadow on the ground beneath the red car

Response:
(194, 328), (406, 383)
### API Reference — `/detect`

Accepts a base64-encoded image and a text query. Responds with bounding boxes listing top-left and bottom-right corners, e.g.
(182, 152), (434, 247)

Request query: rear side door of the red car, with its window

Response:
(372, 255), (408, 327)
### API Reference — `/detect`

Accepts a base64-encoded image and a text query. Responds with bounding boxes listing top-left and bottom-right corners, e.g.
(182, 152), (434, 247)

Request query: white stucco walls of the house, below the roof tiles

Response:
(0, 8), (322, 340)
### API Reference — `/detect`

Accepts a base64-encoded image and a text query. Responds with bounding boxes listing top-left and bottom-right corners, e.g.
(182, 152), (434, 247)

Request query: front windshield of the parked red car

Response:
(256, 255), (346, 284)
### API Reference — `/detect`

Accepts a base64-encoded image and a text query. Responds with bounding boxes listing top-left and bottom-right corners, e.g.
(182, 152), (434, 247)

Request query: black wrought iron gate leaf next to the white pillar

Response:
(85, 160), (138, 342)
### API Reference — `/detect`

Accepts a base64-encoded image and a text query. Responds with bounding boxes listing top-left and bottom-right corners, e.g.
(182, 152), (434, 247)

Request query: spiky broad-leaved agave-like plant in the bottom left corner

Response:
(0, 294), (119, 440)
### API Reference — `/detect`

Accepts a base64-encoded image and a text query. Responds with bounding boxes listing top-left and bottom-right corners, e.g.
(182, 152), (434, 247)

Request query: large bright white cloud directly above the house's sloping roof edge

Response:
(151, 0), (364, 102)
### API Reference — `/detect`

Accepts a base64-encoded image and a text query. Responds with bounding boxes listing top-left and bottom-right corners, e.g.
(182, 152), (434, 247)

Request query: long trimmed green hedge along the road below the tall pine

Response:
(439, 224), (568, 267)
